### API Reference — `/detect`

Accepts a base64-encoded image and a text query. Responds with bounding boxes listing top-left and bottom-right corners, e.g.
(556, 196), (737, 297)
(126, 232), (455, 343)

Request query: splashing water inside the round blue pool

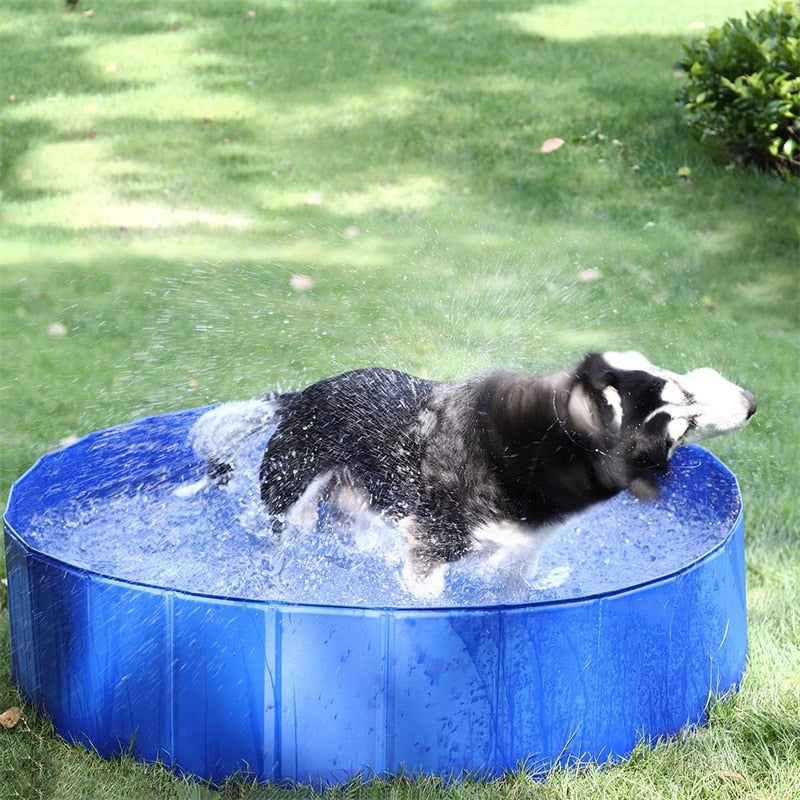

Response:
(17, 422), (737, 607)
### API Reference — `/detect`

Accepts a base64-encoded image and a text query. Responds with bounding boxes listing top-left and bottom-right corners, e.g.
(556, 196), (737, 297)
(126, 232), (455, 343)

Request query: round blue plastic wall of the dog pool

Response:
(4, 410), (747, 784)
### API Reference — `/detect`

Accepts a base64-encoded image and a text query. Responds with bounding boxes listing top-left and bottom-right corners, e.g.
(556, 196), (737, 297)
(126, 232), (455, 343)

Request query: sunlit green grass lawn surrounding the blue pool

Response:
(0, 0), (800, 800)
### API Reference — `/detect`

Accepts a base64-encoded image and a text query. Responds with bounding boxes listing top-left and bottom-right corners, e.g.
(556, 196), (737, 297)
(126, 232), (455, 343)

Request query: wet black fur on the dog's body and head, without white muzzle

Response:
(260, 354), (673, 571)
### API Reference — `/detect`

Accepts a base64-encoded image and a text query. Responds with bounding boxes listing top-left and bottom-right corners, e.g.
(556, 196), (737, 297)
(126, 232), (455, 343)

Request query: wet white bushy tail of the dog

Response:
(174, 393), (291, 497)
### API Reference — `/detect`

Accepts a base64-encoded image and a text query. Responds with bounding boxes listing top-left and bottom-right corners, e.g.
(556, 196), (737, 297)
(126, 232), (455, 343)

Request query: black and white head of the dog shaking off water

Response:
(567, 352), (756, 497)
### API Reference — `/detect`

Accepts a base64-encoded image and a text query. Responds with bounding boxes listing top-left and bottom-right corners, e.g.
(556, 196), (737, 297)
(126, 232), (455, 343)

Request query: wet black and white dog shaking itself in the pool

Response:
(181, 352), (756, 594)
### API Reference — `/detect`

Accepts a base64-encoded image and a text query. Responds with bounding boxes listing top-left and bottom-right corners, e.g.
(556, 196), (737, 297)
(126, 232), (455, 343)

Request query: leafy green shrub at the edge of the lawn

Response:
(678, 2), (800, 172)
